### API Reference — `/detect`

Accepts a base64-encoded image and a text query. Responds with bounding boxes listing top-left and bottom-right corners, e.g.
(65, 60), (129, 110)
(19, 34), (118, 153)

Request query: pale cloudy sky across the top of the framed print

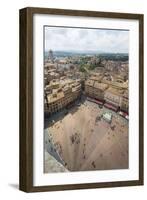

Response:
(45, 27), (129, 53)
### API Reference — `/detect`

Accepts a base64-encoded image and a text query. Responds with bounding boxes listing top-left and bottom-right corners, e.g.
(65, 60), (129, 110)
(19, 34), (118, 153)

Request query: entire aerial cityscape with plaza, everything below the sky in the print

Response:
(44, 50), (129, 173)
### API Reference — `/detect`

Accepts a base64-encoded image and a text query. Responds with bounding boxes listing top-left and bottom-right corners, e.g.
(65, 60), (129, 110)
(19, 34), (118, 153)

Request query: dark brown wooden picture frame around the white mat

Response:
(19, 7), (144, 192)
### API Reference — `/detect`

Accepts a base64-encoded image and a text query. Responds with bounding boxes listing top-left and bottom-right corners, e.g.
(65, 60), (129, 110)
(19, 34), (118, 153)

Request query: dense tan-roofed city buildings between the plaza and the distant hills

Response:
(44, 50), (129, 115)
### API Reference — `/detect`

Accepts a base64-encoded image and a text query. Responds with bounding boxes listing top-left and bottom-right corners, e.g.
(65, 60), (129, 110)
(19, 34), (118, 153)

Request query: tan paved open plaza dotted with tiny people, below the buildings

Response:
(46, 100), (129, 171)
